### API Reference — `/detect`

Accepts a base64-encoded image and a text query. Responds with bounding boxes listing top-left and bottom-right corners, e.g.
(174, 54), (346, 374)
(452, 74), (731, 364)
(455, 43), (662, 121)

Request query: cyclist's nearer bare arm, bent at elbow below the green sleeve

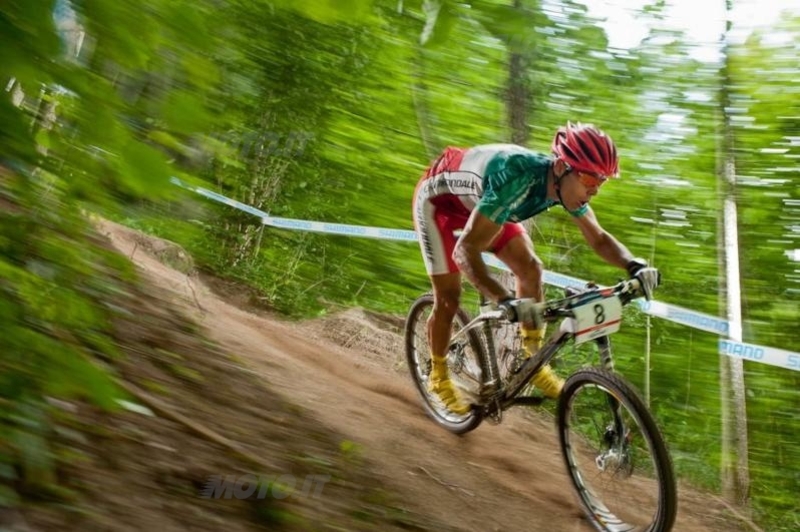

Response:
(453, 209), (508, 302)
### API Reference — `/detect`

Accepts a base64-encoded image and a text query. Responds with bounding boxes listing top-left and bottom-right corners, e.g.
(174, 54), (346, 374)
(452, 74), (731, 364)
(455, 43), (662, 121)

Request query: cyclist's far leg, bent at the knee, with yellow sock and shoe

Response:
(494, 224), (564, 398)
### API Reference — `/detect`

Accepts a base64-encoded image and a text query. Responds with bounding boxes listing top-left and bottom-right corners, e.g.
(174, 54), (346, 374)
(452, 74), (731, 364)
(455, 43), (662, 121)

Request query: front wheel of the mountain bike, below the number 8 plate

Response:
(557, 368), (678, 532)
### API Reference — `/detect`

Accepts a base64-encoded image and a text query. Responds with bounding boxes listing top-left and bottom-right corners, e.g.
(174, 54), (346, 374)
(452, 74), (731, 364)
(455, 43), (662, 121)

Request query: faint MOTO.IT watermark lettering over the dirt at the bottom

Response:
(200, 474), (331, 499)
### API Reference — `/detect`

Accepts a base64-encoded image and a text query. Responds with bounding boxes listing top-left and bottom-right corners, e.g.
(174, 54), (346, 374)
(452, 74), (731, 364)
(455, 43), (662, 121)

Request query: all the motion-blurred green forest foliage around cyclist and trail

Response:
(0, 0), (800, 531)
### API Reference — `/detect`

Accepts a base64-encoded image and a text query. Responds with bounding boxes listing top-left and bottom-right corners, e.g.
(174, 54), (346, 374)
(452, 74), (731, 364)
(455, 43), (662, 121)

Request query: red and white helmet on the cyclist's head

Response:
(552, 122), (619, 177)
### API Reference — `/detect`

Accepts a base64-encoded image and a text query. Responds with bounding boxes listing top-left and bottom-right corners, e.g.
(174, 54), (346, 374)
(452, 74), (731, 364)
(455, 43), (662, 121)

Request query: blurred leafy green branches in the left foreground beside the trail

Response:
(0, 0), (222, 505)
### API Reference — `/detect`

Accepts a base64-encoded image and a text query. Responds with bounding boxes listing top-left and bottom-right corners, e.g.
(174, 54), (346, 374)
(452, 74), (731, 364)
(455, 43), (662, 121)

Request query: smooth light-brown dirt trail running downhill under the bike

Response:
(100, 218), (735, 532)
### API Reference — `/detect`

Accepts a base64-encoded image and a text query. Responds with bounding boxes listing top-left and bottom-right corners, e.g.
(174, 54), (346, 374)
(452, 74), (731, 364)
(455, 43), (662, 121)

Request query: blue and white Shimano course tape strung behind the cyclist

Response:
(171, 177), (800, 371)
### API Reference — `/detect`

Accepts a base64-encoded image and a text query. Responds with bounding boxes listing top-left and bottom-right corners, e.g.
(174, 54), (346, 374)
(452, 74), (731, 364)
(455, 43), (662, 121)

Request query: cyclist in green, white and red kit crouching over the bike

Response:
(413, 122), (647, 414)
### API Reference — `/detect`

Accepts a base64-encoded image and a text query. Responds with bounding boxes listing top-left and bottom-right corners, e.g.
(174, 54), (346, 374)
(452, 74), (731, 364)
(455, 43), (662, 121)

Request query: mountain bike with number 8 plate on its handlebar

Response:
(405, 279), (677, 532)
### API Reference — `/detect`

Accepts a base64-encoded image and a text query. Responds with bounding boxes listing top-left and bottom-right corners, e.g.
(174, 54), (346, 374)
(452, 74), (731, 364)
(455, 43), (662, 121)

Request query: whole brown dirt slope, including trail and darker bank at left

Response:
(12, 218), (739, 532)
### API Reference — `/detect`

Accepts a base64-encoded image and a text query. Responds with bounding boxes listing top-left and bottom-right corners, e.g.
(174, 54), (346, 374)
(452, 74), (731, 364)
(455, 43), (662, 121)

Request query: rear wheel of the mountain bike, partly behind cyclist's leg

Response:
(405, 294), (486, 434)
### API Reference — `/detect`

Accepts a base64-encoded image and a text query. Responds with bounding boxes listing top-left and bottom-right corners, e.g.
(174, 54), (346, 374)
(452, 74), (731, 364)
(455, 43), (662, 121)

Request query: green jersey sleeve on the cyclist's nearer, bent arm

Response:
(476, 154), (530, 225)
